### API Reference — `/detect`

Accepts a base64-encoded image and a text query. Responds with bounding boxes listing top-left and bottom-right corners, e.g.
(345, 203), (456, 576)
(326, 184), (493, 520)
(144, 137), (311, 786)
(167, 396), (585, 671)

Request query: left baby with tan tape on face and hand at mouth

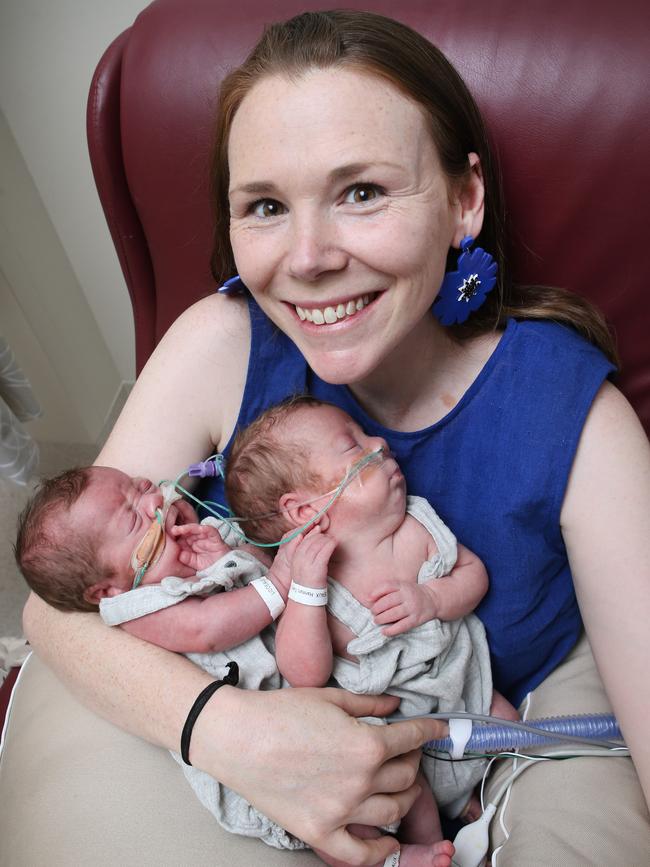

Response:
(16, 467), (289, 653)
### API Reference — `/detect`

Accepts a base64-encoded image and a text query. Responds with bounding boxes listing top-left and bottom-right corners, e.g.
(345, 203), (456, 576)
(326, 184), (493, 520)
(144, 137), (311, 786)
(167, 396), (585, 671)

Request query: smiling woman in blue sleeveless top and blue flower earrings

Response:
(26, 13), (650, 864)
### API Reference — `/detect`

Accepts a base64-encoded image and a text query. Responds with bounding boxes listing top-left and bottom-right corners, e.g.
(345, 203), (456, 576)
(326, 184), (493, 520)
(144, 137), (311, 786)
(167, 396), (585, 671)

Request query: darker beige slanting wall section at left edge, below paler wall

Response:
(0, 112), (121, 444)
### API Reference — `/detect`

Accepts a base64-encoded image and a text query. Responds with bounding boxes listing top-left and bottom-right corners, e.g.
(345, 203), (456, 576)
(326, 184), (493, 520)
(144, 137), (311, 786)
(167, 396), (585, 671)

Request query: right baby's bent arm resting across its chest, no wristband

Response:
(370, 545), (488, 635)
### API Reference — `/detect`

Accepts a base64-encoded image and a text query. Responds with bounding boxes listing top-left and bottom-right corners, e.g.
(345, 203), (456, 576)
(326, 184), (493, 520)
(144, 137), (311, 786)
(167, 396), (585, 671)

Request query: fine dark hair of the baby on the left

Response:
(14, 467), (113, 611)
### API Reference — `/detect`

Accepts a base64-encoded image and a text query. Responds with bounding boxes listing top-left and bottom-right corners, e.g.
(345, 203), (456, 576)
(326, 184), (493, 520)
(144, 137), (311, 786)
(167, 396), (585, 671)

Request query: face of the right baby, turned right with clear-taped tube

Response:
(286, 406), (406, 531)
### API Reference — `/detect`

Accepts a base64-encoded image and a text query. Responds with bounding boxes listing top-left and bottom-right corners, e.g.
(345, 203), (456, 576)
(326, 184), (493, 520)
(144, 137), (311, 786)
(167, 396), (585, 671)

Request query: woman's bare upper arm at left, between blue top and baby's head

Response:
(96, 295), (250, 482)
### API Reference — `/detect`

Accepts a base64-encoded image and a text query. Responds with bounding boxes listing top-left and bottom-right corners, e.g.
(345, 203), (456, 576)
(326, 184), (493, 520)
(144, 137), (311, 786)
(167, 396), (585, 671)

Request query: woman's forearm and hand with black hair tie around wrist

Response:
(25, 594), (444, 865)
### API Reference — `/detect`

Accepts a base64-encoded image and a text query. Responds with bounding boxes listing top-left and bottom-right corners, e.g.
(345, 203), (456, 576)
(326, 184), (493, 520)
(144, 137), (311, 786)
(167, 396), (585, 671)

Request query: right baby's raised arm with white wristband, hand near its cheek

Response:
(275, 527), (335, 686)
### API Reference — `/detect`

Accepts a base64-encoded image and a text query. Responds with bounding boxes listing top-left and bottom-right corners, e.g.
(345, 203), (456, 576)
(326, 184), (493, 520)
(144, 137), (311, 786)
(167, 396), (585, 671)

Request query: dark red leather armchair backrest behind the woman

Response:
(88, 0), (650, 430)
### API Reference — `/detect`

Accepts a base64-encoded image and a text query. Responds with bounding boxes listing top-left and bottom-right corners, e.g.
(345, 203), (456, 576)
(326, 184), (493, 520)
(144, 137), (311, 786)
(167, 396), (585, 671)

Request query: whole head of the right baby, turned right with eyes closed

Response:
(226, 396), (405, 542)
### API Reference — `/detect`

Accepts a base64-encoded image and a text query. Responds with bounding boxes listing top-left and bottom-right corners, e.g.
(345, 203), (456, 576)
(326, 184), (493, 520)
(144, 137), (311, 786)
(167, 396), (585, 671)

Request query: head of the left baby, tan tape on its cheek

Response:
(15, 467), (196, 611)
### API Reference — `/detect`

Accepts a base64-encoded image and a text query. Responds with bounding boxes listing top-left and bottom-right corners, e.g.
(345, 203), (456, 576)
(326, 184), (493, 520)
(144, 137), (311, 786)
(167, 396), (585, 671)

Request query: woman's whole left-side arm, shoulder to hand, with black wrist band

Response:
(24, 296), (443, 864)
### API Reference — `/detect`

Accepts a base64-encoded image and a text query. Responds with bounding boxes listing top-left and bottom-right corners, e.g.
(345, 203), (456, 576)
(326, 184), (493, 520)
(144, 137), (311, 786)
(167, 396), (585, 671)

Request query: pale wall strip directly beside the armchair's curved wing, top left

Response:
(0, 0), (147, 386)
